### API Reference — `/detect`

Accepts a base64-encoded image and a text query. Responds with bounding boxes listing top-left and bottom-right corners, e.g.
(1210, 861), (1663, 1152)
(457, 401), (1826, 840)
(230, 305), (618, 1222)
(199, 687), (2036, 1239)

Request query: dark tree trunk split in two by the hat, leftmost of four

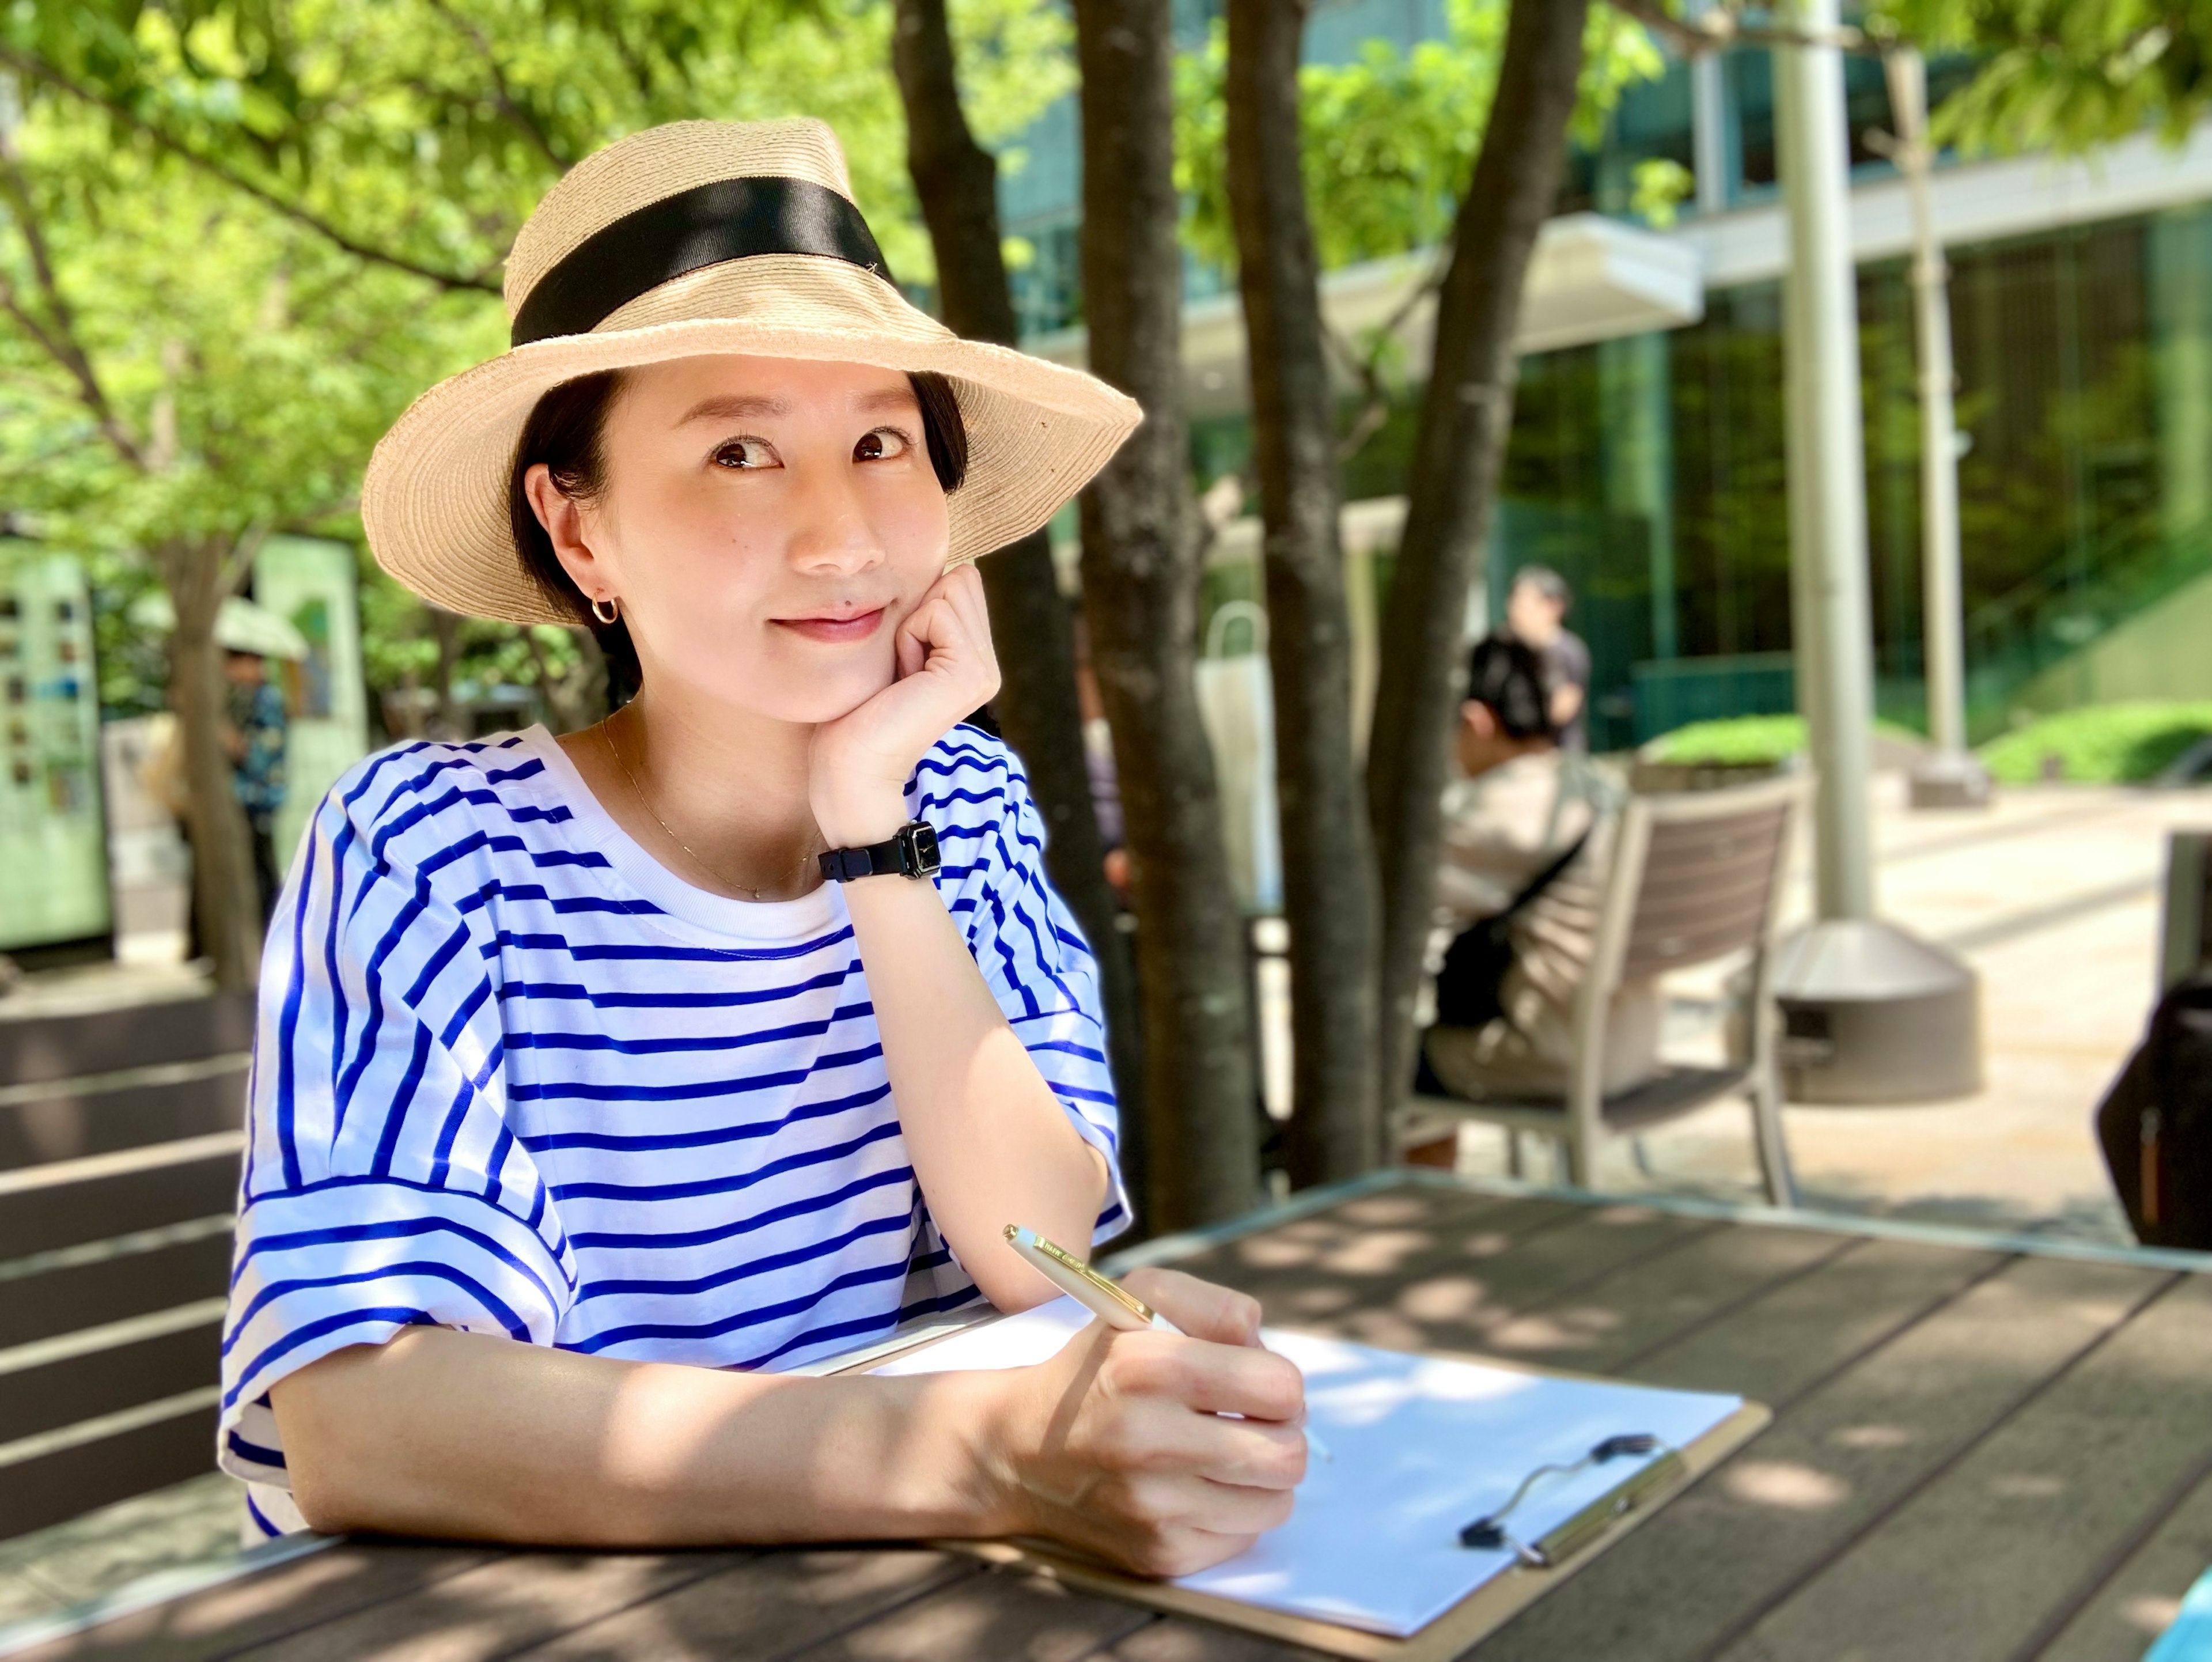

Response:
(892, 0), (1150, 1222)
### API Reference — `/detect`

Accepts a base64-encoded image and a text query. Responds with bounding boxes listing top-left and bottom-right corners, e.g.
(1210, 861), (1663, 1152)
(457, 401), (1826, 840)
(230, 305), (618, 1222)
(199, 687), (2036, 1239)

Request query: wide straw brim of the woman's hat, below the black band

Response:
(361, 255), (1141, 624)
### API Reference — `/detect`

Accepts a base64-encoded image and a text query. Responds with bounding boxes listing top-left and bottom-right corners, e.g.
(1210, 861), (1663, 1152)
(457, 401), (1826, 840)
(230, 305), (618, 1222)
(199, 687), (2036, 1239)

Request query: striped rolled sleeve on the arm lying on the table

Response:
(219, 752), (575, 1487)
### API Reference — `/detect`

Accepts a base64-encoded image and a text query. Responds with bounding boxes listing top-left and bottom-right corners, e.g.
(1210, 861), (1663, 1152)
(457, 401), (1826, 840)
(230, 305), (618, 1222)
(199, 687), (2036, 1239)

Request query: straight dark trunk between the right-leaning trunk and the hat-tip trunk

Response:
(1228, 0), (1382, 1186)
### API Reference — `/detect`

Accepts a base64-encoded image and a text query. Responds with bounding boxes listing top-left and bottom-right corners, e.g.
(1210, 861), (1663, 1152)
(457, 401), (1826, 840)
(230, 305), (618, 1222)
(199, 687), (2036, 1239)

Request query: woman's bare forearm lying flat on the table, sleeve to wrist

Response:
(274, 1328), (1013, 1547)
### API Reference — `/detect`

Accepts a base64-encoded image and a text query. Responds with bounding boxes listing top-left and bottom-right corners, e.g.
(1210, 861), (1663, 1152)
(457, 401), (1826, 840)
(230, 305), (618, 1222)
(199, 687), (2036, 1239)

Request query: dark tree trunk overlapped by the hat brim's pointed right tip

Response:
(1075, 0), (1259, 1228)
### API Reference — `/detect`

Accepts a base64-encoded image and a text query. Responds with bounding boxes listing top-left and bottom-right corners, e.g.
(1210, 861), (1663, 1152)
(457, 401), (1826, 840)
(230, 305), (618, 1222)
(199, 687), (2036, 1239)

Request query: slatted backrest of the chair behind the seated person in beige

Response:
(1597, 779), (1803, 985)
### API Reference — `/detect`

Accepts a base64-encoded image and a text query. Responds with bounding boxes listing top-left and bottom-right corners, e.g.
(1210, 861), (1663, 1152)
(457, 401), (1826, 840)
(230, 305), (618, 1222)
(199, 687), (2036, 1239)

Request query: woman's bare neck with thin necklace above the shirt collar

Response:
(562, 684), (823, 901)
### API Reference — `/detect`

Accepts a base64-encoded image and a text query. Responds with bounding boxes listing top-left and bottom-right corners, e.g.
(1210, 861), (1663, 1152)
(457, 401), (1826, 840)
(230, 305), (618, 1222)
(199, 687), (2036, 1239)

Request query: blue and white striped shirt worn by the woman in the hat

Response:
(219, 726), (1128, 1534)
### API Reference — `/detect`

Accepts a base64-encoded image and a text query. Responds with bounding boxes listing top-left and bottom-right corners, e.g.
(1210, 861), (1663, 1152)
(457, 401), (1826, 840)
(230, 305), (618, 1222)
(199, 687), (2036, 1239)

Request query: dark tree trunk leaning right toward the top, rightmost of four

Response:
(1367, 0), (1588, 1133)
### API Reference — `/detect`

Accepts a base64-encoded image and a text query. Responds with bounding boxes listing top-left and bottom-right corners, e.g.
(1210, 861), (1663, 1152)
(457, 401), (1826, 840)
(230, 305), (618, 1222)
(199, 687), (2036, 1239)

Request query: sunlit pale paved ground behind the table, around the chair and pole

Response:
(1462, 777), (2212, 1241)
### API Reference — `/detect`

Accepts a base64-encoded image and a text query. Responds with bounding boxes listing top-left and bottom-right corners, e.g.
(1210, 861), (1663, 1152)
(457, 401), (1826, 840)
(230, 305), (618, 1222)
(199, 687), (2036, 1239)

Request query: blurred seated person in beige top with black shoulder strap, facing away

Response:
(1422, 635), (1659, 1133)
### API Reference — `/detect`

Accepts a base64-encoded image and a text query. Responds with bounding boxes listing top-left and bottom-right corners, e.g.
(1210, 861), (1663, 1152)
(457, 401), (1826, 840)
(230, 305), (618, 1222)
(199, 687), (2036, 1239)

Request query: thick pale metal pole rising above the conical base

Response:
(1774, 0), (1873, 918)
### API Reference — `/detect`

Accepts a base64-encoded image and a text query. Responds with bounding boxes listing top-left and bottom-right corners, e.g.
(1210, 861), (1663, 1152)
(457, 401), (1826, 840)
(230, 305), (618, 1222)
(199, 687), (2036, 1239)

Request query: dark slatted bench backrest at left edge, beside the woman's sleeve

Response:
(0, 998), (255, 1540)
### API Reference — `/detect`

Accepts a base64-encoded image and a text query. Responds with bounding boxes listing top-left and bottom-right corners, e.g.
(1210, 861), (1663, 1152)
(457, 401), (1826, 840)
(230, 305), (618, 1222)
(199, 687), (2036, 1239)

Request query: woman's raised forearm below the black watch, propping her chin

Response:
(845, 876), (1108, 1310)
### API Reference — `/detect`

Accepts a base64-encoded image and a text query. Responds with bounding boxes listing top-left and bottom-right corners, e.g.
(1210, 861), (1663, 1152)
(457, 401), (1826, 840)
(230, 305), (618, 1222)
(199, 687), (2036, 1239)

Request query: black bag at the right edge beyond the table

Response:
(2097, 971), (2212, 1252)
